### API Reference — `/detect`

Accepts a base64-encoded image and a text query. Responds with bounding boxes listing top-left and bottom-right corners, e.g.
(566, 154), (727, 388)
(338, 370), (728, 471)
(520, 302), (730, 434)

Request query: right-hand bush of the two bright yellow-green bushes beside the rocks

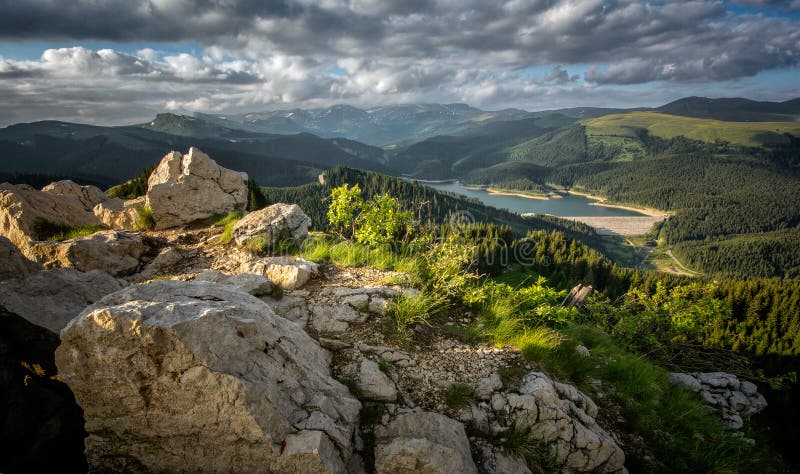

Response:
(355, 194), (413, 245)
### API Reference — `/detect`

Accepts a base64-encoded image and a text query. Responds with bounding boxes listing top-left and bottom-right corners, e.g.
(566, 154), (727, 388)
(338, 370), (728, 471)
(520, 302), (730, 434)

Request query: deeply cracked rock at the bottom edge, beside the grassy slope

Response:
(506, 372), (625, 472)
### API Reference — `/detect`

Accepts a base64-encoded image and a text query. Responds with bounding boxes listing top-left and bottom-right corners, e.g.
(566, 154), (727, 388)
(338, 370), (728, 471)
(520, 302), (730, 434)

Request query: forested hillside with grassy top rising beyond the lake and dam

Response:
(444, 112), (800, 277)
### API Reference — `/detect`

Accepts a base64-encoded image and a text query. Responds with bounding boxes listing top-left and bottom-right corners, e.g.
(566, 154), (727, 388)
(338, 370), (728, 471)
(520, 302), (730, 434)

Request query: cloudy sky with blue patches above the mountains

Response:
(0, 0), (800, 126)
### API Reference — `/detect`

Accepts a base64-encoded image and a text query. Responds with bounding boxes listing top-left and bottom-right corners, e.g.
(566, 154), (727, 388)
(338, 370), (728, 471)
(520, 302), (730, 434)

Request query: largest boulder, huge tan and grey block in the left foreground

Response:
(56, 281), (361, 472)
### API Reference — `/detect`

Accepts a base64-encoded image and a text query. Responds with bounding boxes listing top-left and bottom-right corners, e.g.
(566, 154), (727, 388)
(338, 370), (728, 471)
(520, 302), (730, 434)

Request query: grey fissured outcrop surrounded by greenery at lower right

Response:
(669, 372), (767, 430)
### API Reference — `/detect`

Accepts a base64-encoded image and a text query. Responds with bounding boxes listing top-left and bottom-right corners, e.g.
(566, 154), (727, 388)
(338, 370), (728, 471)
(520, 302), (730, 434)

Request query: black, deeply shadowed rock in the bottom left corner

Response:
(0, 308), (87, 473)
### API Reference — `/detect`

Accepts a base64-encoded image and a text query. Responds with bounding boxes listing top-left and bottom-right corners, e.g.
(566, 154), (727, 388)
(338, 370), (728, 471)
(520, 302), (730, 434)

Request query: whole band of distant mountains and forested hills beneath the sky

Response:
(0, 97), (800, 276)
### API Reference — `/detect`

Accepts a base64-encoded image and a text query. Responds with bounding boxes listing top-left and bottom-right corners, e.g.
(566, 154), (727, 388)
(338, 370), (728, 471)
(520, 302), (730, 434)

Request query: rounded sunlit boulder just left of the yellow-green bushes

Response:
(233, 204), (311, 249)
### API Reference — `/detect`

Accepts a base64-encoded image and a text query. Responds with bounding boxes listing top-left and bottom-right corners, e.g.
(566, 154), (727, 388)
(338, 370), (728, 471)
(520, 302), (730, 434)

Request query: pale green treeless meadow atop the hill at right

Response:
(584, 112), (800, 147)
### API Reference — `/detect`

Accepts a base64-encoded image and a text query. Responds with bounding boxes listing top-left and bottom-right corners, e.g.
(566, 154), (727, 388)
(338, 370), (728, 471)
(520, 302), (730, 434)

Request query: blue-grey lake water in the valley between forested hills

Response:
(418, 181), (644, 217)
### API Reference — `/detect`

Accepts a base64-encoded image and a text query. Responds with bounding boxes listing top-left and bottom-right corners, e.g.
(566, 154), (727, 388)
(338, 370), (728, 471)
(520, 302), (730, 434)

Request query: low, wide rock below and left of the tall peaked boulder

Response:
(30, 230), (151, 276)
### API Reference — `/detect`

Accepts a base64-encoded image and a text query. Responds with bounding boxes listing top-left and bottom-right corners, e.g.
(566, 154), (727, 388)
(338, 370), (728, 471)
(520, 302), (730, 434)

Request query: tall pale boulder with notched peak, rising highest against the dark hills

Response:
(146, 147), (247, 229)
